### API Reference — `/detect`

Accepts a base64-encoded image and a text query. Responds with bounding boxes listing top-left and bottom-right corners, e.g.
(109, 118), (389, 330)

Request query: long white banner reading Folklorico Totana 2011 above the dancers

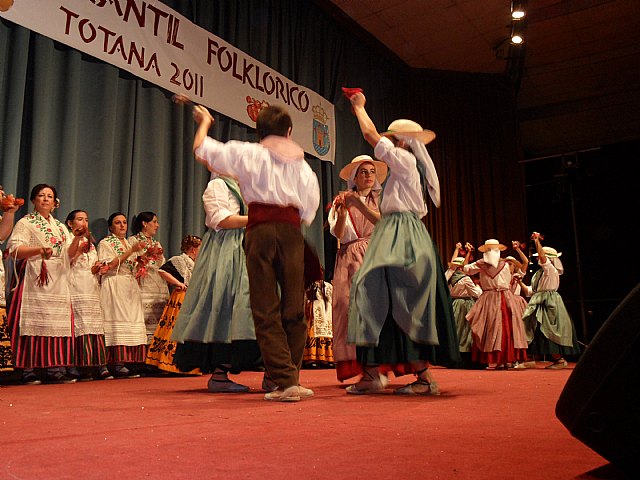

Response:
(0, 0), (335, 162)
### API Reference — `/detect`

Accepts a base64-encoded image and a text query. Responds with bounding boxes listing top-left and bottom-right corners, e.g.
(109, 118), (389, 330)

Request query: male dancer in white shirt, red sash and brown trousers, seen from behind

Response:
(193, 105), (320, 402)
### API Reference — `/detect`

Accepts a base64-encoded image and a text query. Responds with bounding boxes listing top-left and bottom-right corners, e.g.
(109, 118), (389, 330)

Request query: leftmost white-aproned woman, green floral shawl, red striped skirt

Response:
(8, 183), (84, 384)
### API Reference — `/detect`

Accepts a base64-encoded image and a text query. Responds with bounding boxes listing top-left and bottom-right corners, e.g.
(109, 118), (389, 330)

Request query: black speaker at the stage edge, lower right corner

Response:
(556, 284), (640, 478)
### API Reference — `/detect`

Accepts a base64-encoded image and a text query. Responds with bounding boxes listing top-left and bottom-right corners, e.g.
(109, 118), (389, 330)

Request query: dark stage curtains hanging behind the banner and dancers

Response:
(0, 0), (527, 279)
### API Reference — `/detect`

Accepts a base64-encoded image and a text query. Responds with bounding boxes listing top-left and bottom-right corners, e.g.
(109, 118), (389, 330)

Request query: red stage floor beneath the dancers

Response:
(0, 364), (624, 480)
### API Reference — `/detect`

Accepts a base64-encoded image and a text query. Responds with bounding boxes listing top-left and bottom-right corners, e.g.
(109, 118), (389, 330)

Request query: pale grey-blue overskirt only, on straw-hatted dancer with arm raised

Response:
(348, 212), (439, 346)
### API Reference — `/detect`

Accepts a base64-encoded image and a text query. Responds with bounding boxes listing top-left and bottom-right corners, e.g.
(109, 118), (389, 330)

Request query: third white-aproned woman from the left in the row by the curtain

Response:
(98, 212), (147, 378)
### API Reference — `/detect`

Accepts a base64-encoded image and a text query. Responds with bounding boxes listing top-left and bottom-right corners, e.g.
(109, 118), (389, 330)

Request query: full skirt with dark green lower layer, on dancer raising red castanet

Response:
(348, 212), (460, 367)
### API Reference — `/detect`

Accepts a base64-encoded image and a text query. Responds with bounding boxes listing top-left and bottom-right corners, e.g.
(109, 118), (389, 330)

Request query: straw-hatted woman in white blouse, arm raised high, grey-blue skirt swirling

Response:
(347, 92), (460, 395)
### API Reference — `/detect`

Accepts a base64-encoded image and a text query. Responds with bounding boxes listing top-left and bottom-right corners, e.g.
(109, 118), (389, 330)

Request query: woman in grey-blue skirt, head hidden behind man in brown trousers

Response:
(172, 175), (264, 393)
